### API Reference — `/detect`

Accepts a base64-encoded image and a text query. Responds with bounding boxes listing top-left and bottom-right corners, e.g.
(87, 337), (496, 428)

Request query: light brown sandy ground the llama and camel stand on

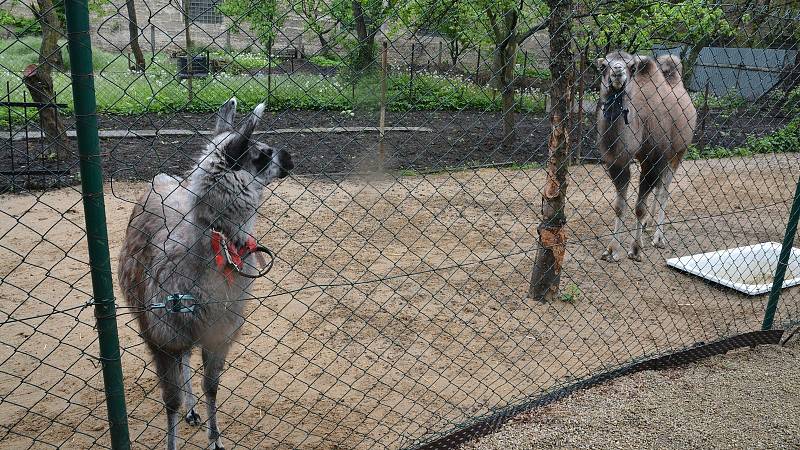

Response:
(0, 154), (800, 449)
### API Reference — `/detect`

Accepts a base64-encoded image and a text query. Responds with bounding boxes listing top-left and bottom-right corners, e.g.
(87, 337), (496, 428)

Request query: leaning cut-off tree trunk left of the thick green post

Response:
(22, 64), (72, 161)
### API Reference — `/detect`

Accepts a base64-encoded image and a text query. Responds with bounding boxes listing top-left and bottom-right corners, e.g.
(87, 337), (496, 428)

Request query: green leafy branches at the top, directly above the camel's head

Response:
(592, 0), (734, 56)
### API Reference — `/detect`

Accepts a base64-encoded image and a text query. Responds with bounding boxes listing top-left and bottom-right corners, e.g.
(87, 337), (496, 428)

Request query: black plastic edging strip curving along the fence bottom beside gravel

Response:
(415, 330), (783, 450)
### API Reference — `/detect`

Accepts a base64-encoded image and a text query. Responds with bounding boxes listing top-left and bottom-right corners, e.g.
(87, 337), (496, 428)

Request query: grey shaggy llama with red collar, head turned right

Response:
(119, 98), (293, 450)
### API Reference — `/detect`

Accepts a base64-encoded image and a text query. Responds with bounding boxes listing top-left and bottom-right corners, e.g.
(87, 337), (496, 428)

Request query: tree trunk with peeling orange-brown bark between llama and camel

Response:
(528, 0), (574, 301)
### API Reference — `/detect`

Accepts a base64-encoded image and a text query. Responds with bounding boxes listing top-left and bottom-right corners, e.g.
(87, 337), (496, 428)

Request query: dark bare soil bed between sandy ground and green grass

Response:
(0, 111), (788, 192)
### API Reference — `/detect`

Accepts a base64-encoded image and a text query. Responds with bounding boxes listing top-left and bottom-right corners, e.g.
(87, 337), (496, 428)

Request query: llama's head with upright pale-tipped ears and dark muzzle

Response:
(212, 97), (294, 184)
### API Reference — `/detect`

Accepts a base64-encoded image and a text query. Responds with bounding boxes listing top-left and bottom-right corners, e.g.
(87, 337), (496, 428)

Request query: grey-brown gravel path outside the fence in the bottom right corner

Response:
(465, 336), (800, 450)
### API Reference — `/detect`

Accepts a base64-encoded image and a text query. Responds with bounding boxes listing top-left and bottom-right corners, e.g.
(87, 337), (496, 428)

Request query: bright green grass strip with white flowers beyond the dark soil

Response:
(0, 36), (544, 123)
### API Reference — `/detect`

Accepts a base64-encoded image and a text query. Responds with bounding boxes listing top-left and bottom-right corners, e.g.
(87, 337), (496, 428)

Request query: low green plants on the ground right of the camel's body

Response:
(686, 118), (800, 160)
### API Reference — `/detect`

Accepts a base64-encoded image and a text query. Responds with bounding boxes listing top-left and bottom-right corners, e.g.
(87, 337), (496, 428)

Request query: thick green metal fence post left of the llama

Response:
(64, 0), (130, 450)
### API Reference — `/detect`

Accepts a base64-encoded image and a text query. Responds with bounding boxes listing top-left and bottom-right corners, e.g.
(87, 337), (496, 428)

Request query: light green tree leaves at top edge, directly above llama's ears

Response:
(217, 0), (286, 51)
